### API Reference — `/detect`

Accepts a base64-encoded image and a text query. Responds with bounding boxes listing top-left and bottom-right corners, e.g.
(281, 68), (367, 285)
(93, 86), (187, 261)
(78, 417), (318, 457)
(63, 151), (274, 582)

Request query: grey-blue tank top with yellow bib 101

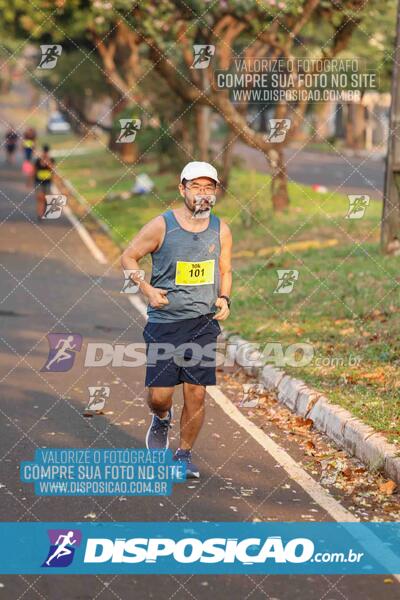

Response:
(147, 210), (221, 323)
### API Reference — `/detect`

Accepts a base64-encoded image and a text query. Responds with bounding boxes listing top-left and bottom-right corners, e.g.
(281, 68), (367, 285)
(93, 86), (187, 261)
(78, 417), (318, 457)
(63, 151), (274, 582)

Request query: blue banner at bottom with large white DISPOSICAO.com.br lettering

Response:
(0, 522), (400, 575)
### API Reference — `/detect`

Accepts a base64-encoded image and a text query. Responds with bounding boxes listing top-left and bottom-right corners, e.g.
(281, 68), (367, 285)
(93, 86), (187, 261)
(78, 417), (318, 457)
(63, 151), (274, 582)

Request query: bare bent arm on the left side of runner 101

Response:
(121, 215), (168, 308)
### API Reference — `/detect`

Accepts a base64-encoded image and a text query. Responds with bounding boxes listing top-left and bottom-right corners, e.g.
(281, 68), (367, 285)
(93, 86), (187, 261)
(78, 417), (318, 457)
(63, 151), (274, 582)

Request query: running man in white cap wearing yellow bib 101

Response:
(121, 162), (232, 478)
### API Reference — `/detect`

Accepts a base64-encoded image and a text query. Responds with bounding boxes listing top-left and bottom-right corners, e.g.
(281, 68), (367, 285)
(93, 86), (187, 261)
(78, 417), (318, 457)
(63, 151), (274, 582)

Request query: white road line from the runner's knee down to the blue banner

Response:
(207, 385), (359, 523)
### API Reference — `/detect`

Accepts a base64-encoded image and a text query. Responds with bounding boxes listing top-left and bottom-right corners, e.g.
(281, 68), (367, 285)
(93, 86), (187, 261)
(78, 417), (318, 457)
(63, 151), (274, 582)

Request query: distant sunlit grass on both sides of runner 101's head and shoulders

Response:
(58, 146), (381, 252)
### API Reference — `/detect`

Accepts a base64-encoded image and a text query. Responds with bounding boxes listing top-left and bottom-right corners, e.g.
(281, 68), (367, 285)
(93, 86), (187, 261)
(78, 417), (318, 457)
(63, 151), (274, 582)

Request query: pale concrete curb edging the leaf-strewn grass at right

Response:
(223, 332), (400, 484)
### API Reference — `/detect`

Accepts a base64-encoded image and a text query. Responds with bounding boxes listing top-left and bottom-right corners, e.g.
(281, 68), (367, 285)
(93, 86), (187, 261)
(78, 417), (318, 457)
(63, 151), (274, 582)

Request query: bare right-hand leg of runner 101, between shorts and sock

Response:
(179, 382), (206, 450)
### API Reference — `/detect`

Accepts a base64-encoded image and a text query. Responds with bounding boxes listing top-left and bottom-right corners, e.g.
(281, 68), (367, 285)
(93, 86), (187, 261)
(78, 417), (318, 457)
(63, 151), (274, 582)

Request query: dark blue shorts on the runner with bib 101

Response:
(143, 314), (221, 387)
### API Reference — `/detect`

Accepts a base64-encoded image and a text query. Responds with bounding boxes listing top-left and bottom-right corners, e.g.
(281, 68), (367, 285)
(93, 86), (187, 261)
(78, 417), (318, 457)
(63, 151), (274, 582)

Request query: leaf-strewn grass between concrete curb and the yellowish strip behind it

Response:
(229, 244), (400, 442)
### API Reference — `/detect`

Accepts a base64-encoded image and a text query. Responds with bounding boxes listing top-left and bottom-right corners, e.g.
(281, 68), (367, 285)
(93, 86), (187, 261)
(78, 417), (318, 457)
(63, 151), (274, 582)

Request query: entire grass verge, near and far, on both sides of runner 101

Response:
(58, 146), (400, 443)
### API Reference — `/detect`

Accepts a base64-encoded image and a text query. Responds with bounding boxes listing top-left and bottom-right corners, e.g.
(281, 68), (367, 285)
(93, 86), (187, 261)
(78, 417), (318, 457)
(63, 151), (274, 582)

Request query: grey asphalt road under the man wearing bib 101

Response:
(0, 162), (399, 600)
